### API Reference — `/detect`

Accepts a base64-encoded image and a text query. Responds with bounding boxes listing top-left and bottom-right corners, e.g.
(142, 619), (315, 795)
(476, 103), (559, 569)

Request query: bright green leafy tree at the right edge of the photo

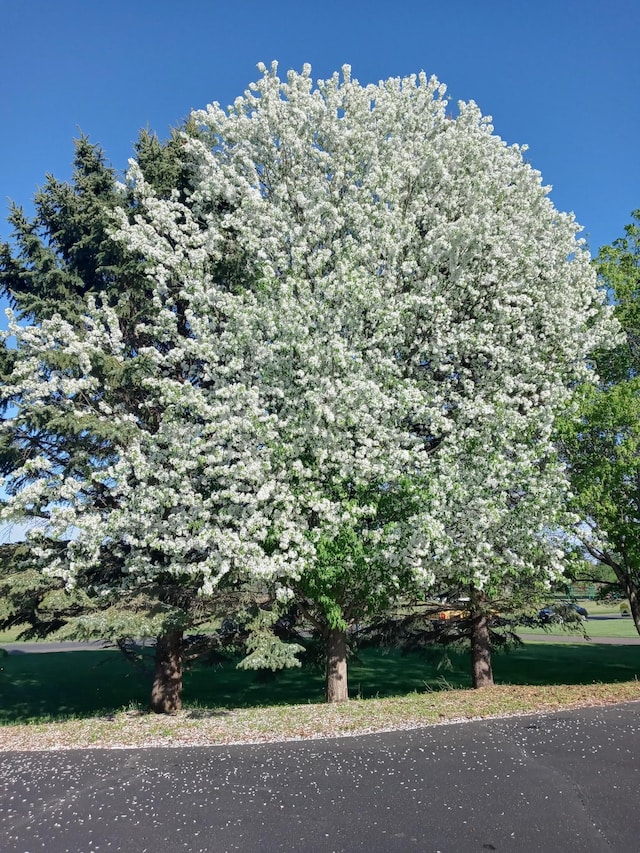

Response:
(561, 211), (640, 632)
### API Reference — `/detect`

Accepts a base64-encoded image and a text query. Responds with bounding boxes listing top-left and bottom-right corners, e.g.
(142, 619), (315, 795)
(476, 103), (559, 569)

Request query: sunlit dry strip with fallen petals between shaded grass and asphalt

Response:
(0, 680), (640, 752)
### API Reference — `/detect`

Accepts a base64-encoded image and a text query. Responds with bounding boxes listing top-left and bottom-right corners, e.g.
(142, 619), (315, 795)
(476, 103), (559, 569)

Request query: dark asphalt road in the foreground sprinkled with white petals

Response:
(0, 703), (640, 853)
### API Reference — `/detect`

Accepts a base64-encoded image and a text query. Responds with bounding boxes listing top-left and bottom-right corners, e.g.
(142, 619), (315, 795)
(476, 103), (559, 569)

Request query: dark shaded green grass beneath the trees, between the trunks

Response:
(0, 642), (640, 724)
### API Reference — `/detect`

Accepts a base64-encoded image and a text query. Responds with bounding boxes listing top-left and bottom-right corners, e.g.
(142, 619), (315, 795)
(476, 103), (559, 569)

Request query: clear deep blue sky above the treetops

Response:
(0, 0), (640, 260)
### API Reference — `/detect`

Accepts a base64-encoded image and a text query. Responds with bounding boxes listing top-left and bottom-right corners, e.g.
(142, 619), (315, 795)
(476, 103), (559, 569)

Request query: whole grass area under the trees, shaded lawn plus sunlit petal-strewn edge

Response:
(0, 643), (640, 751)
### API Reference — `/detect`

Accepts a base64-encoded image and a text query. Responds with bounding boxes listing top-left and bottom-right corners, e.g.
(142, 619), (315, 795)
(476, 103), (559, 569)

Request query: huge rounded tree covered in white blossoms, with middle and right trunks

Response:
(3, 66), (609, 701)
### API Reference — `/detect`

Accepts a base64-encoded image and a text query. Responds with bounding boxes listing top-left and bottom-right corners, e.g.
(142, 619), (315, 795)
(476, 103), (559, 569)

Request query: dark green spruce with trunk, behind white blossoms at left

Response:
(0, 130), (296, 712)
